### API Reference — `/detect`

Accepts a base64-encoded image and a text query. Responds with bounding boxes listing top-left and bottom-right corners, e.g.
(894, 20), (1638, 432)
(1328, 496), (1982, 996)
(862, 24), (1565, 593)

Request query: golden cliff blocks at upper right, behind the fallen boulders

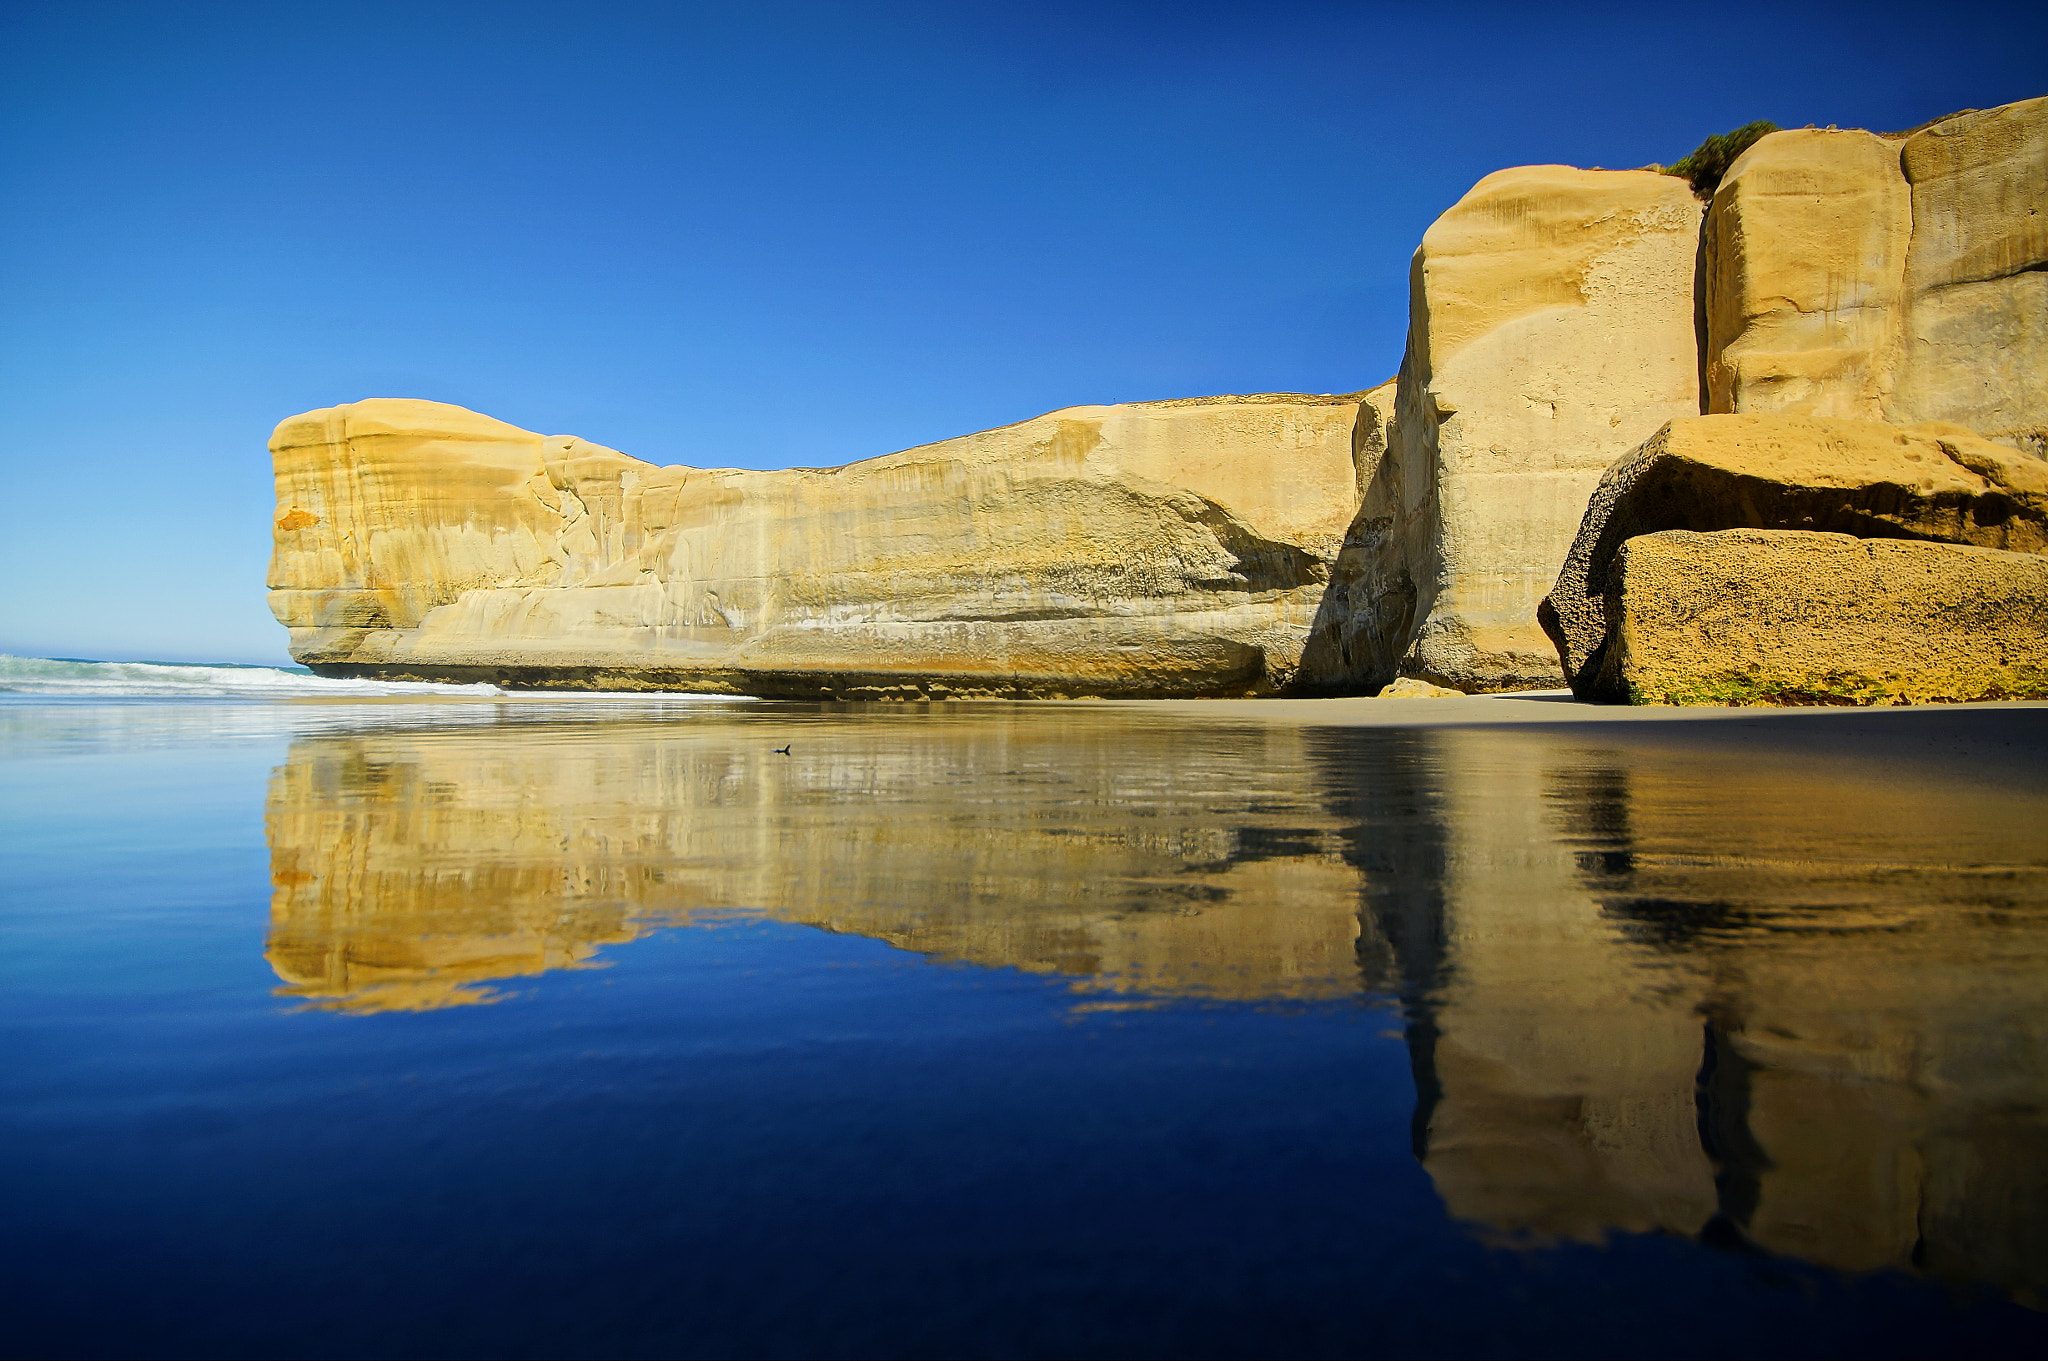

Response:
(1702, 98), (2048, 454)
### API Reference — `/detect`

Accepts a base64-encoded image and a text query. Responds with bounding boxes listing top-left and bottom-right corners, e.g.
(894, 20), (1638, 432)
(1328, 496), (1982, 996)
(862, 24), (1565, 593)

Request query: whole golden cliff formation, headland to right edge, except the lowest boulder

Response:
(270, 98), (2048, 698)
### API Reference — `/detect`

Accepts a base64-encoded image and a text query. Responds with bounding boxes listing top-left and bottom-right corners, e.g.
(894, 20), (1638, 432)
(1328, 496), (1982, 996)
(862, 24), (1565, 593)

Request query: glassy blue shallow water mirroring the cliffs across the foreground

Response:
(0, 696), (2048, 1357)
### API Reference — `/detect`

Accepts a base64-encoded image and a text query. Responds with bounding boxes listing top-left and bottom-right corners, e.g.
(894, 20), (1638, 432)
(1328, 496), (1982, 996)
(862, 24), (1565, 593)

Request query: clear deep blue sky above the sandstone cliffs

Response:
(12, 0), (2048, 661)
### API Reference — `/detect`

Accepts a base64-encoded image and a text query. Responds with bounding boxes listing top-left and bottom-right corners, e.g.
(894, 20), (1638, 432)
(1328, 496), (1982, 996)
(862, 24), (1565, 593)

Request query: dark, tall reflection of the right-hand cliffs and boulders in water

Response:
(1319, 714), (2048, 1304)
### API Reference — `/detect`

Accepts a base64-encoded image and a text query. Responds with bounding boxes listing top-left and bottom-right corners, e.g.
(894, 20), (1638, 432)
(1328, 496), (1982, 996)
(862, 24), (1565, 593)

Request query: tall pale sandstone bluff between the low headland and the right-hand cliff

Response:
(1311, 166), (1700, 692)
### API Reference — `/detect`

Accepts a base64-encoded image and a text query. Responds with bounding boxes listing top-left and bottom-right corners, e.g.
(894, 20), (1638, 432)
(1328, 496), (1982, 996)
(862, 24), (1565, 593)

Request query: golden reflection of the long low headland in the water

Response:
(268, 710), (1360, 1009)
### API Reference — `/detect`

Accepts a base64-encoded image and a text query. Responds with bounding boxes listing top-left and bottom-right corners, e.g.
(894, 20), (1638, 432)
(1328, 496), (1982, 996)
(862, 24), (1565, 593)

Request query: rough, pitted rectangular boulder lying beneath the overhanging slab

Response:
(1591, 530), (2048, 704)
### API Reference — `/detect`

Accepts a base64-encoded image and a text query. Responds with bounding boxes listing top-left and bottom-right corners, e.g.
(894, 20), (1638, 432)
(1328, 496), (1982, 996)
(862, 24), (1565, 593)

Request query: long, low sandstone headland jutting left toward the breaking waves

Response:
(270, 395), (1360, 698)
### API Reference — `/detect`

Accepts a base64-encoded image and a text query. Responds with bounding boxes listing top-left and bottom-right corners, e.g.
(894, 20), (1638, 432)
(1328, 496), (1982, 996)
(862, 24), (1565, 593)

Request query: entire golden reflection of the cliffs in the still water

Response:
(268, 708), (2048, 1300)
